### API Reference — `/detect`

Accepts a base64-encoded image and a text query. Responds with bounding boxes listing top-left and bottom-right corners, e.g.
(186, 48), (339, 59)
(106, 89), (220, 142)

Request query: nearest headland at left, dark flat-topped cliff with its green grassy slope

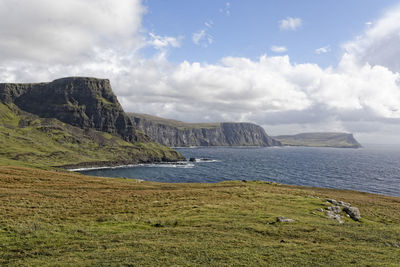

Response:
(0, 77), (184, 168)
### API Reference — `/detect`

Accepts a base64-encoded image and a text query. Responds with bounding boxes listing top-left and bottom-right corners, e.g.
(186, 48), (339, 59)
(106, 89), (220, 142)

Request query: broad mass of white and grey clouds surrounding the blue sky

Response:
(0, 0), (400, 143)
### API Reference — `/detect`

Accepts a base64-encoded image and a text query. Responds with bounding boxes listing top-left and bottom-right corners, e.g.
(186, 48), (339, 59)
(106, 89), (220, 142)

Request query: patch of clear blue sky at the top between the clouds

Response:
(143, 0), (399, 67)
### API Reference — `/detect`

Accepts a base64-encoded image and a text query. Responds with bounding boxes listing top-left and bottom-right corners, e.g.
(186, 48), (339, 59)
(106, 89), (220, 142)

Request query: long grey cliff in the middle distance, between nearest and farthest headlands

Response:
(128, 113), (281, 147)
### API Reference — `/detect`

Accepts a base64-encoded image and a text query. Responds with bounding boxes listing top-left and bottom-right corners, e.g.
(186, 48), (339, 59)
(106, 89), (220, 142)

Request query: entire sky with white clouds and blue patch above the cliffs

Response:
(0, 0), (400, 143)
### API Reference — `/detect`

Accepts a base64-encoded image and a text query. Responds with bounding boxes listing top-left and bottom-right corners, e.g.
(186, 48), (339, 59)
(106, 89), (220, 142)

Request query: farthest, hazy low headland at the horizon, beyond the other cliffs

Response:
(273, 132), (361, 148)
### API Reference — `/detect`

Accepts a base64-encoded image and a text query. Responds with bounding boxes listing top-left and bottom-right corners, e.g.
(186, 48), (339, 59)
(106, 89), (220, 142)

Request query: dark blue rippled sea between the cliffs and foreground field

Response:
(79, 146), (400, 196)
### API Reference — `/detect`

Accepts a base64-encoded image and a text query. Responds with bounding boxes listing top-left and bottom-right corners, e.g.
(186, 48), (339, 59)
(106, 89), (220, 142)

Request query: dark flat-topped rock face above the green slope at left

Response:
(0, 77), (146, 142)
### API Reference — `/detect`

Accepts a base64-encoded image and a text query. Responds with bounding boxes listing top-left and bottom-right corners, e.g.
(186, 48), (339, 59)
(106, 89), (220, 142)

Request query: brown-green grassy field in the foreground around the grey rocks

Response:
(0, 166), (400, 266)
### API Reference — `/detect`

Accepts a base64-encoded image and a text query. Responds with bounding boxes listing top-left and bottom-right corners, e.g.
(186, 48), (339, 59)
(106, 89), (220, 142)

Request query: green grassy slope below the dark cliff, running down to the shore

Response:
(0, 103), (181, 168)
